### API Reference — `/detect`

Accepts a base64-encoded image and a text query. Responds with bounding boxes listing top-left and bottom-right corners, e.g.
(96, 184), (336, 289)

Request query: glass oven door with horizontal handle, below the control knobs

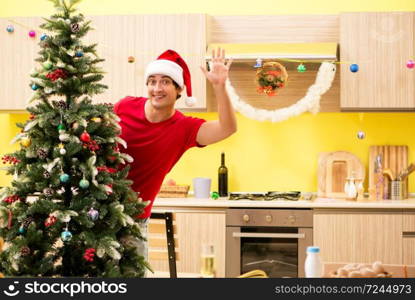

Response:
(226, 227), (313, 278)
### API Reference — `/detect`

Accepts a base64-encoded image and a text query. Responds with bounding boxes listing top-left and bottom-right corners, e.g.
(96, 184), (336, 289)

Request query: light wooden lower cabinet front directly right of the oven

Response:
(313, 209), (402, 264)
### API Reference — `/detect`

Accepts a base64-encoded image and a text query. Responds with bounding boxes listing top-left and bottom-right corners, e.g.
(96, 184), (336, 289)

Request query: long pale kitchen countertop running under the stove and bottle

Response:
(154, 197), (415, 210)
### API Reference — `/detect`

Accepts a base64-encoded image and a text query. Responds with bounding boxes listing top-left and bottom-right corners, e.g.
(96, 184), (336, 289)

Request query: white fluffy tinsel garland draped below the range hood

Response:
(226, 62), (336, 122)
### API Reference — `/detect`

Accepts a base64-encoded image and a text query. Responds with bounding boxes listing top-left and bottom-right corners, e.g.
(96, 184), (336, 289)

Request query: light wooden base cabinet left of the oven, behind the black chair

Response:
(149, 209), (226, 278)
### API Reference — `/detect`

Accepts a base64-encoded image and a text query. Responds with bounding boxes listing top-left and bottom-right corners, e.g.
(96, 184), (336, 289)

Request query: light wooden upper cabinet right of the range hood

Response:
(340, 12), (415, 111)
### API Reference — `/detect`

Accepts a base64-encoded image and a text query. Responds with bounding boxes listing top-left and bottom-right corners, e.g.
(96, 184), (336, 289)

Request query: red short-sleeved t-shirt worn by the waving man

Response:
(114, 96), (206, 218)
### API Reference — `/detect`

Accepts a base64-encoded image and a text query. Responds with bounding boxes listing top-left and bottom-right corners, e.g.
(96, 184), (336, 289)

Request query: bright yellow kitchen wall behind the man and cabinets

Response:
(0, 0), (415, 192)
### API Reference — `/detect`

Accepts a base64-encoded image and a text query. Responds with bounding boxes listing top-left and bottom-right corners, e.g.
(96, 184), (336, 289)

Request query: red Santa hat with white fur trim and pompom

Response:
(144, 50), (196, 106)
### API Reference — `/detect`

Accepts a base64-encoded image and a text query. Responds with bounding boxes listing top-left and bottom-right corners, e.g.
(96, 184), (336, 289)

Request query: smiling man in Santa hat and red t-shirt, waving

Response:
(114, 49), (236, 219)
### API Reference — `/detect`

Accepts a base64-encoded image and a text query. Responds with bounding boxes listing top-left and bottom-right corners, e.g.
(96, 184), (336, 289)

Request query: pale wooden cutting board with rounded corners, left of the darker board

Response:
(317, 151), (365, 198)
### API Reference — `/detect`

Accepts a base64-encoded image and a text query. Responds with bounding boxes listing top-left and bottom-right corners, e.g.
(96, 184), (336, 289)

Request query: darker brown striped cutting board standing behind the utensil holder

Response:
(369, 145), (408, 199)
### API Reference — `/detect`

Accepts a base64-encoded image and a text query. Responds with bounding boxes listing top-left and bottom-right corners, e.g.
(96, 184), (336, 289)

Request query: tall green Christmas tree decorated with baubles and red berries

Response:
(0, 0), (149, 277)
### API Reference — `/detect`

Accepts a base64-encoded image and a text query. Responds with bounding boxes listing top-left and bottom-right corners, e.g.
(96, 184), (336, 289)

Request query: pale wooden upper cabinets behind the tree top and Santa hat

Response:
(0, 14), (206, 111)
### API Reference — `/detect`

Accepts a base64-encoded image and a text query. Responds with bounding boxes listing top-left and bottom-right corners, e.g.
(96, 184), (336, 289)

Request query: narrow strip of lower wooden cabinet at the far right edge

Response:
(402, 212), (415, 265)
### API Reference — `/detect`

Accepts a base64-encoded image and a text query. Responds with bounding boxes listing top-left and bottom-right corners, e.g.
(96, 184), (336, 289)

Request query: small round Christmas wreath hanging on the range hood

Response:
(256, 62), (288, 96)
